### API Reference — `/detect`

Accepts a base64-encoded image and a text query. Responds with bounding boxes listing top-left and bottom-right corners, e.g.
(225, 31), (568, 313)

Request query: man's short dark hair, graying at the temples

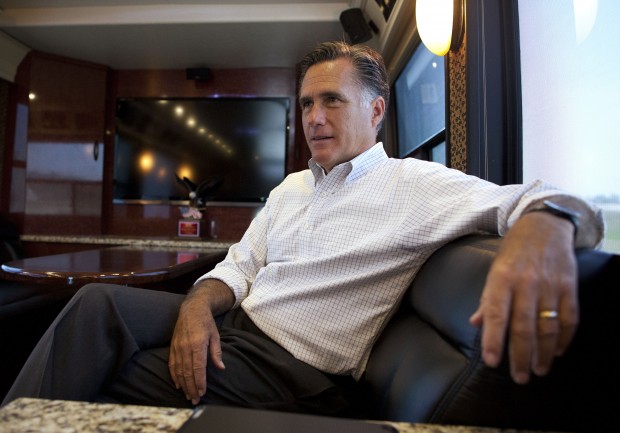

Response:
(299, 41), (390, 131)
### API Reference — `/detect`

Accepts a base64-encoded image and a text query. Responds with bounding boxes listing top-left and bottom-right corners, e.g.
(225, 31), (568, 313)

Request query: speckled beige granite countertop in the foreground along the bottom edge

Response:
(0, 398), (548, 433)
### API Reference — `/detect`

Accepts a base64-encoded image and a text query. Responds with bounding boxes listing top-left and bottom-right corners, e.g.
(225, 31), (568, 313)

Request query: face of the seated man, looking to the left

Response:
(299, 59), (385, 172)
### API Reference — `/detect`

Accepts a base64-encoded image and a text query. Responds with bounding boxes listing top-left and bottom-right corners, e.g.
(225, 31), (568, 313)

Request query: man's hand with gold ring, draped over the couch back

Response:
(470, 212), (579, 384)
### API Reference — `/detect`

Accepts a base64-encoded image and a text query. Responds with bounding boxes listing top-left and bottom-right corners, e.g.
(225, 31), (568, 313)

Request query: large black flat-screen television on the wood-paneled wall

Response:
(114, 97), (290, 204)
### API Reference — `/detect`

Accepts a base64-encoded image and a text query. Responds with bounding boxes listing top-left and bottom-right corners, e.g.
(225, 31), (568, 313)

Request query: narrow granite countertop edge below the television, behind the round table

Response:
(19, 234), (232, 249)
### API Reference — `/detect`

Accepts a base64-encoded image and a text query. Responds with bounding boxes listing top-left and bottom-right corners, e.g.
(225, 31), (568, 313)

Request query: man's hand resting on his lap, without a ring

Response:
(168, 280), (234, 404)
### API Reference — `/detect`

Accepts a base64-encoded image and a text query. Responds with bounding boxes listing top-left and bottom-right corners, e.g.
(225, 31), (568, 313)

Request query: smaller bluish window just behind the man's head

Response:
(393, 44), (446, 165)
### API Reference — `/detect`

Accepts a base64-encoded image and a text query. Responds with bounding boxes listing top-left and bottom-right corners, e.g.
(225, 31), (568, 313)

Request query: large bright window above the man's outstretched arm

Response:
(518, 0), (620, 253)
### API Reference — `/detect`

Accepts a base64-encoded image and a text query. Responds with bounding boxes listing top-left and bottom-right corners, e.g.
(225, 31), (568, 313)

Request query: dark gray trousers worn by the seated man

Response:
(3, 284), (355, 415)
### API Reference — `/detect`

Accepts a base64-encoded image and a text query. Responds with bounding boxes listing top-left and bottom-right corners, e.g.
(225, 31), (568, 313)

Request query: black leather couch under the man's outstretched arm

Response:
(363, 236), (620, 432)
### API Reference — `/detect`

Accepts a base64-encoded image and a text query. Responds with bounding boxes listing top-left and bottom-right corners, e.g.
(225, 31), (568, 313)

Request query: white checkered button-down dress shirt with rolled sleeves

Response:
(202, 143), (588, 379)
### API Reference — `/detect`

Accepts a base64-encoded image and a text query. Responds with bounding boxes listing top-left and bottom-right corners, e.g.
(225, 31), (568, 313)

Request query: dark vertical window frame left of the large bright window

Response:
(466, 0), (523, 185)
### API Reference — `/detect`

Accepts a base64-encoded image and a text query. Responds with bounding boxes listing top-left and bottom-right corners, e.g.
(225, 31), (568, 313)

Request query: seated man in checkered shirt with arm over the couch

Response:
(5, 43), (603, 414)
